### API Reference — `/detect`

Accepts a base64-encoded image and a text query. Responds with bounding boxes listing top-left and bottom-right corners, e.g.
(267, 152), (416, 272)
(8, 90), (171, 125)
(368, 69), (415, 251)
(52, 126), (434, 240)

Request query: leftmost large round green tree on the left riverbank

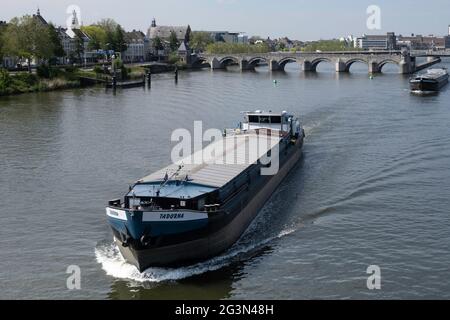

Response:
(3, 15), (54, 72)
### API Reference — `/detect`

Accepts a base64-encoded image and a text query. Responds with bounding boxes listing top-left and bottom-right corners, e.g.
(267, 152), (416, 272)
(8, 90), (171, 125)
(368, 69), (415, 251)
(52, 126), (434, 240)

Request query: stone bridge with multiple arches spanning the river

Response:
(192, 51), (440, 74)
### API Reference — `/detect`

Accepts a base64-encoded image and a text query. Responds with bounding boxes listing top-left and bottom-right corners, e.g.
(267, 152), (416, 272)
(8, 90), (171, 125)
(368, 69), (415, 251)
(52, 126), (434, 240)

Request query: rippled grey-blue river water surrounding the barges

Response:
(0, 62), (450, 299)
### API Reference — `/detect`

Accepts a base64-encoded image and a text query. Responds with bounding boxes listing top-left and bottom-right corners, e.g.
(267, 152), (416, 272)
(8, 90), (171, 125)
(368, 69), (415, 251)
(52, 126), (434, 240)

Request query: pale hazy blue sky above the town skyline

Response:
(0, 0), (450, 40)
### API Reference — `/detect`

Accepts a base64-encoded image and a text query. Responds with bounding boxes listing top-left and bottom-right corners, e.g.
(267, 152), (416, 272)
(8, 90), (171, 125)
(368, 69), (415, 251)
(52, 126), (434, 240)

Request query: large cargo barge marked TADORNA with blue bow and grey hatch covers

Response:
(106, 111), (305, 272)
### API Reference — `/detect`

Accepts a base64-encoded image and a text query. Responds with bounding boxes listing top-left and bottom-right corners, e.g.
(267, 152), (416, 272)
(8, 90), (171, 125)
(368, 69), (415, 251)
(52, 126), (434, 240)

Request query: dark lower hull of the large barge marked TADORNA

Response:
(115, 139), (303, 272)
